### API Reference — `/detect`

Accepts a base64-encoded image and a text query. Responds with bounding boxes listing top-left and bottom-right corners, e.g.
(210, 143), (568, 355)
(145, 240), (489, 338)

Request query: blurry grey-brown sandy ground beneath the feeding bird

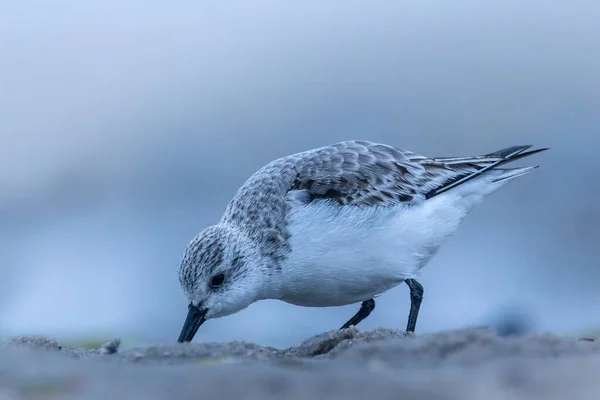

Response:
(0, 328), (600, 400)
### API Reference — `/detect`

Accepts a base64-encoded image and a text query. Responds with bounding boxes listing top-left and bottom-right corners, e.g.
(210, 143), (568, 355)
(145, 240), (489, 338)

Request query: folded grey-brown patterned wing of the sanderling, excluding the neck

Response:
(289, 141), (541, 206)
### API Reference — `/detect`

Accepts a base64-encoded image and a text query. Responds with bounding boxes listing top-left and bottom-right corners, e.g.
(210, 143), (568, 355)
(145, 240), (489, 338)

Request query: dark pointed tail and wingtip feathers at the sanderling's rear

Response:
(426, 145), (548, 198)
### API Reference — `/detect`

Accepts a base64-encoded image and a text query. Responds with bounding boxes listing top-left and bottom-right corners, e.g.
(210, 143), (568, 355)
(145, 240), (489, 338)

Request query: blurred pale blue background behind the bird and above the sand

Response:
(0, 0), (600, 346)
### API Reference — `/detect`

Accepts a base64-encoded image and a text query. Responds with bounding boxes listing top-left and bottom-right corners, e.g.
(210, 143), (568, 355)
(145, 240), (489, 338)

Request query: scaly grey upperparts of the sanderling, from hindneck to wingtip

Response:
(221, 141), (544, 241)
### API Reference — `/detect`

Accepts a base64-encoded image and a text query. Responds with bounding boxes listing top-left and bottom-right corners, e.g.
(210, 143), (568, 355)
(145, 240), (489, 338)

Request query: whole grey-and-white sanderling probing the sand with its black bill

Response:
(178, 141), (547, 342)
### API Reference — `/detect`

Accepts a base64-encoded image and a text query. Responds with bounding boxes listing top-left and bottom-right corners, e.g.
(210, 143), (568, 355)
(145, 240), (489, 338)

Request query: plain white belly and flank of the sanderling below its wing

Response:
(280, 191), (471, 307)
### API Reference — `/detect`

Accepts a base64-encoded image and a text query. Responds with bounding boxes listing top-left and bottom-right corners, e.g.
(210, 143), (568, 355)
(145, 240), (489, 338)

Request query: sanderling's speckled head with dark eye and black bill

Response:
(178, 225), (269, 342)
